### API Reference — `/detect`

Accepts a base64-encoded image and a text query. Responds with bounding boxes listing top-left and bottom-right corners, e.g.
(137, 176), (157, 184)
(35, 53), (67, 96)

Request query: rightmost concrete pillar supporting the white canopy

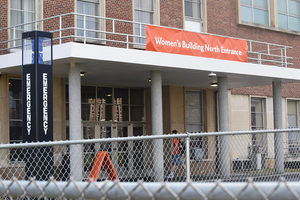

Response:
(273, 81), (284, 174)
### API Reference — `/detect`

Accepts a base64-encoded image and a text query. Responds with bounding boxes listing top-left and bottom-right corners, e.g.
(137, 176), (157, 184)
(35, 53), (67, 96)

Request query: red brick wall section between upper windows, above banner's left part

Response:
(160, 0), (183, 29)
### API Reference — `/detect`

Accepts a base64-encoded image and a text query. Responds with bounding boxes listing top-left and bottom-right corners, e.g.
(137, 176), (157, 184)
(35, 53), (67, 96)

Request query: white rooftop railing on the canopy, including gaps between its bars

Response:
(0, 13), (293, 67)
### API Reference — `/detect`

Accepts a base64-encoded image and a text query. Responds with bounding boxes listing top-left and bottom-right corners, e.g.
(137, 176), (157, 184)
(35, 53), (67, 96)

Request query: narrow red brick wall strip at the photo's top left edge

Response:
(0, 0), (8, 55)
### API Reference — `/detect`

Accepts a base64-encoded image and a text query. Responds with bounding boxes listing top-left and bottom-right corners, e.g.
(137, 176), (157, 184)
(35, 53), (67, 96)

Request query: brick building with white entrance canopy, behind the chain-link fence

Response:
(0, 0), (300, 181)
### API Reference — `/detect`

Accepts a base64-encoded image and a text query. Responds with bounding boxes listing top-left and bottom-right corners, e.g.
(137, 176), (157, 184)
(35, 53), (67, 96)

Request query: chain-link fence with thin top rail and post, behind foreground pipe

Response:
(0, 129), (300, 182)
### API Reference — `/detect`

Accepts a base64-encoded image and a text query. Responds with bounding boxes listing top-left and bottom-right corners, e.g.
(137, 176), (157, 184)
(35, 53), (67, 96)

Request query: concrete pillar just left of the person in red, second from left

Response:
(151, 71), (164, 182)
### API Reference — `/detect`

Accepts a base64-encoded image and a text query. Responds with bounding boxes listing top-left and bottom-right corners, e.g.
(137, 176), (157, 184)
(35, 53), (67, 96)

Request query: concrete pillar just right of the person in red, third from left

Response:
(218, 77), (230, 178)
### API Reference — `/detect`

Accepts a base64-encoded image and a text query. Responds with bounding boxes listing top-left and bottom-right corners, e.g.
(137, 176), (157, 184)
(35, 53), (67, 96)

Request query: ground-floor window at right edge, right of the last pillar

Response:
(287, 100), (300, 154)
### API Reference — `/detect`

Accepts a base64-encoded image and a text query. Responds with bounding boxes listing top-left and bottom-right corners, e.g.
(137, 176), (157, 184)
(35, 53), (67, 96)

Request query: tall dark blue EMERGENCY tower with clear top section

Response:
(22, 31), (54, 180)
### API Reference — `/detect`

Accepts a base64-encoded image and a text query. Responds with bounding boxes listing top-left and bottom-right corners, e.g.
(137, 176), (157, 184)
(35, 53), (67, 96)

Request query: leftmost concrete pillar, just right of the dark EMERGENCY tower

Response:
(69, 63), (83, 181)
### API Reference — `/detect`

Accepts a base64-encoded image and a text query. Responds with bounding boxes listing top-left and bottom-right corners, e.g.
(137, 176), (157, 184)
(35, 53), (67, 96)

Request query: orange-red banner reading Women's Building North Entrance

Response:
(146, 25), (248, 62)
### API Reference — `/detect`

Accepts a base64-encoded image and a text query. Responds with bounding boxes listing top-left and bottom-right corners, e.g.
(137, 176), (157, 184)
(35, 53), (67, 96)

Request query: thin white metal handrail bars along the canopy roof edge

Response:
(0, 12), (293, 67)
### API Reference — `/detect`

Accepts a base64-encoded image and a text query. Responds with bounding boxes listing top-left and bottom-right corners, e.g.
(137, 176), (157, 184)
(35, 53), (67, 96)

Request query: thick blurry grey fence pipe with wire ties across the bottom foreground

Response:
(0, 178), (300, 200)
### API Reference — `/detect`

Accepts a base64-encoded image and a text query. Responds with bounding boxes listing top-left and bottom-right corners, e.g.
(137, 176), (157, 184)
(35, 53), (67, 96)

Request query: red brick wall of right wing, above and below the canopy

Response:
(207, 0), (300, 98)
